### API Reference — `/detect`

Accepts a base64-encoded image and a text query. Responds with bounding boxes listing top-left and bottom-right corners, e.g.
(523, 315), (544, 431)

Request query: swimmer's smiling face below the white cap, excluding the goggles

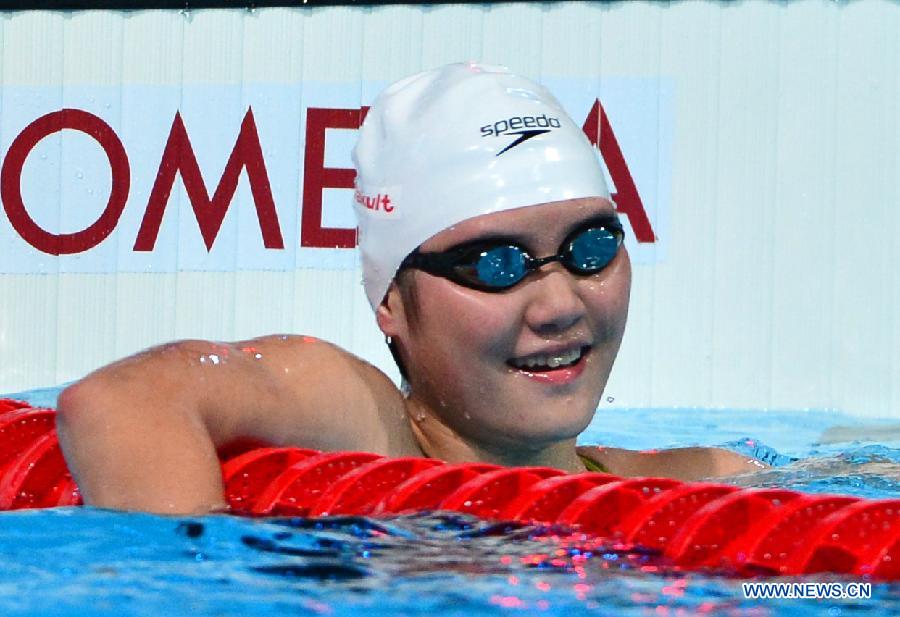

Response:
(378, 198), (631, 458)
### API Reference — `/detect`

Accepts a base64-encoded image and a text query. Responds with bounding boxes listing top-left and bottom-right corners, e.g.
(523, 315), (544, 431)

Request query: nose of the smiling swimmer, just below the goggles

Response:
(525, 263), (586, 335)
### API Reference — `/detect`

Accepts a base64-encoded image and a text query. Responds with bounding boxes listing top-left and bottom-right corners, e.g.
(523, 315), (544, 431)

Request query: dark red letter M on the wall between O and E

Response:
(134, 108), (284, 251)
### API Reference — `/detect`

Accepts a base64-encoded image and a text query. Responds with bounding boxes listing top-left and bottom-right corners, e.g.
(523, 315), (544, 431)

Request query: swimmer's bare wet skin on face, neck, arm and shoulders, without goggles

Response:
(57, 199), (758, 513)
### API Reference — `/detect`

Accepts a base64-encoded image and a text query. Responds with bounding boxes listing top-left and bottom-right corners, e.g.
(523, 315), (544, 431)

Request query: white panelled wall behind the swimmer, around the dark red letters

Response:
(0, 0), (900, 417)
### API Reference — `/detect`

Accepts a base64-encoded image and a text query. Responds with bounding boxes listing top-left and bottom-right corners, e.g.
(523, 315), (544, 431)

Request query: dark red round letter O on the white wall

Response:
(0, 109), (131, 255)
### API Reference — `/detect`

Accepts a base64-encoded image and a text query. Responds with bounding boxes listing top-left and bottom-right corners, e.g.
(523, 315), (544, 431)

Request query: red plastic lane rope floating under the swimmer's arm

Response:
(0, 399), (900, 581)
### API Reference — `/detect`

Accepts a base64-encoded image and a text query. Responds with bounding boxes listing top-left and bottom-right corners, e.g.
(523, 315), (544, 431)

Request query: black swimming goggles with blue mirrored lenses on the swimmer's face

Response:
(400, 217), (625, 292)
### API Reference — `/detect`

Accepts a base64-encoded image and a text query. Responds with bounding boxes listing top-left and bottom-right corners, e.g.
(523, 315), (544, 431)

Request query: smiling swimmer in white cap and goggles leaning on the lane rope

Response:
(57, 63), (762, 513)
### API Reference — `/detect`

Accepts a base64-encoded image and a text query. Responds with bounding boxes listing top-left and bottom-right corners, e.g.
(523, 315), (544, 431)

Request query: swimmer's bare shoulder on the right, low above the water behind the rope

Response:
(579, 446), (768, 480)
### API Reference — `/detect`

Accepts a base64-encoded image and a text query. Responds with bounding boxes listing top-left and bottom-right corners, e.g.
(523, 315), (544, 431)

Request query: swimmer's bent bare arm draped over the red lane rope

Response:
(57, 336), (412, 513)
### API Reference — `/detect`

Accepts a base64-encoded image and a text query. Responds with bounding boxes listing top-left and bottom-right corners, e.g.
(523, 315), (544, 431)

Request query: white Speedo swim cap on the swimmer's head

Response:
(353, 62), (609, 309)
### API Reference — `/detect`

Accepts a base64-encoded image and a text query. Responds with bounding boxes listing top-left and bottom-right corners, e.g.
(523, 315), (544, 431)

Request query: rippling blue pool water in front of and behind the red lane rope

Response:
(0, 382), (900, 617)
